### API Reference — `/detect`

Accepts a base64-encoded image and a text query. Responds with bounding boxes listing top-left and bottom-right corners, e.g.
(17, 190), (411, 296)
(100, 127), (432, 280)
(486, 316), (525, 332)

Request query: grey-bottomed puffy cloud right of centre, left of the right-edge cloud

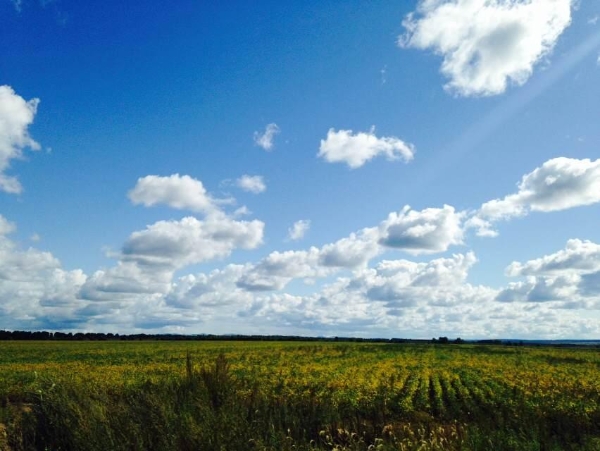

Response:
(379, 205), (464, 255)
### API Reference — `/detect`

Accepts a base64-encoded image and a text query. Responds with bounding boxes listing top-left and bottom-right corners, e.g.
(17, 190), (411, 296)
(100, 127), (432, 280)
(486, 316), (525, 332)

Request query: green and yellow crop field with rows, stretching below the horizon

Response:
(0, 341), (600, 451)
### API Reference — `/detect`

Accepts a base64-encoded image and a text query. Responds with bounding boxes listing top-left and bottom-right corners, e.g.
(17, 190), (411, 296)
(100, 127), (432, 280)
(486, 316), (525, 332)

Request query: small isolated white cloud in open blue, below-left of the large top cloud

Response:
(317, 128), (415, 169)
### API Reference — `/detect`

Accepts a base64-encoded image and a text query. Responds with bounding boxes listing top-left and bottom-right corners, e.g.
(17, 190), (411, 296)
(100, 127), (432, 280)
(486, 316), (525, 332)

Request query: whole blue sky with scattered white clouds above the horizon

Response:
(0, 0), (600, 338)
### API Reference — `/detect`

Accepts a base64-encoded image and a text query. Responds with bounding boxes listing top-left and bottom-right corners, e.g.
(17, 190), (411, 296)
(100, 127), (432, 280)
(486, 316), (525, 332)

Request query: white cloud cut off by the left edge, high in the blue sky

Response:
(0, 86), (40, 194)
